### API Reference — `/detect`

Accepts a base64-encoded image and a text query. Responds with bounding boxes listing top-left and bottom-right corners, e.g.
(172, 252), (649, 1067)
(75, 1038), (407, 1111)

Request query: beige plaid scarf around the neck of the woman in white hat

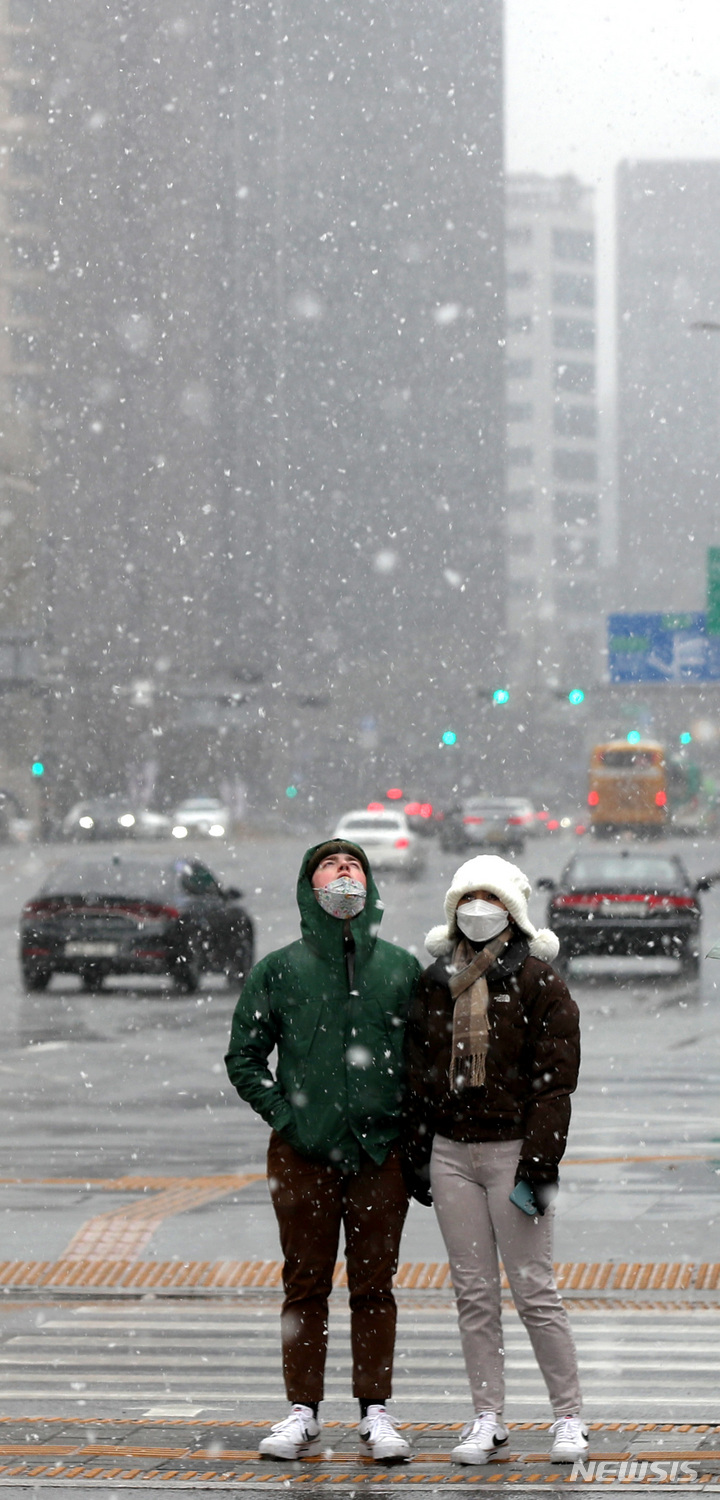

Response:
(450, 927), (512, 1092)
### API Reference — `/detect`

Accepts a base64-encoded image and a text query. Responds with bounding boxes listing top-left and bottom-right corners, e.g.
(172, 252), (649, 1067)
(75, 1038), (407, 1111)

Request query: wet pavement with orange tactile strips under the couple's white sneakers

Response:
(0, 1418), (720, 1490)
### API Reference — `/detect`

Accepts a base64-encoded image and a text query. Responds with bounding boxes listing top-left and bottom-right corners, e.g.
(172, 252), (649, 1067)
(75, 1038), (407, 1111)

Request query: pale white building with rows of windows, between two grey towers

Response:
(506, 174), (600, 689)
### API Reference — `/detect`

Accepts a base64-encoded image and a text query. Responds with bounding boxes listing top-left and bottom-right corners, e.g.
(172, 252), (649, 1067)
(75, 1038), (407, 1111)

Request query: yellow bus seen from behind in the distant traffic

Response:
(588, 740), (668, 837)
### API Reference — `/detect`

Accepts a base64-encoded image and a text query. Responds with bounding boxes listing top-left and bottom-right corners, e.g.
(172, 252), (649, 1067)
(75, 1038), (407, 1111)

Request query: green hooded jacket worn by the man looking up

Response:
(225, 845), (420, 1172)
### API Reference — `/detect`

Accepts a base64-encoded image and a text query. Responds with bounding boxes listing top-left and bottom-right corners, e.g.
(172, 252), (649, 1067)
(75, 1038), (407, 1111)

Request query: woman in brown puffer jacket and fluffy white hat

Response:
(407, 855), (588, 1464)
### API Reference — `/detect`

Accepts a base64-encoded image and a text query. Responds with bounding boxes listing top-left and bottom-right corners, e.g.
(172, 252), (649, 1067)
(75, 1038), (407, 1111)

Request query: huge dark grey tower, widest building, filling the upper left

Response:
(36, 0), (504, 803)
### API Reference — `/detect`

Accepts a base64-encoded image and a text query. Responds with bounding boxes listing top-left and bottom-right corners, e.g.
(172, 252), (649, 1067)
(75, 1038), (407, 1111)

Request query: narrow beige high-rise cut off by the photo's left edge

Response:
(0, 0), (47, 809)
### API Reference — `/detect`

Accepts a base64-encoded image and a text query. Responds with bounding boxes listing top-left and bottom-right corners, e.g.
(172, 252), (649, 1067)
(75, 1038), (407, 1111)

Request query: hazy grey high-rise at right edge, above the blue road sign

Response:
(615, 161), (720, 611)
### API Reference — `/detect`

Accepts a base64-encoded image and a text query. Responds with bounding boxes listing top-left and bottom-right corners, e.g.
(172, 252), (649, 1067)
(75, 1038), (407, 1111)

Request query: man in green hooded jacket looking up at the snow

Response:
(225, 839), (420, 1463)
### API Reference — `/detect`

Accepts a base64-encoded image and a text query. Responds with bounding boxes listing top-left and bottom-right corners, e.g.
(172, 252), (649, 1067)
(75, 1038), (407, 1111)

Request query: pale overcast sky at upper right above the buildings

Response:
(506, 0), (720, 386)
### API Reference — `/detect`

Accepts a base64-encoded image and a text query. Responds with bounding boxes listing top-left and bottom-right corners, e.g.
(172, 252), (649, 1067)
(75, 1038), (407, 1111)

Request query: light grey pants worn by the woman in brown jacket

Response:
(431, 1136), (581, 1418)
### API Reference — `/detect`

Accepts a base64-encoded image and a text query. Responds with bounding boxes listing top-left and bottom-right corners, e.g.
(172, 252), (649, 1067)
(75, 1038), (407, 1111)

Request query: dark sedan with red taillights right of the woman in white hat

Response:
(537, 849), (720, 975)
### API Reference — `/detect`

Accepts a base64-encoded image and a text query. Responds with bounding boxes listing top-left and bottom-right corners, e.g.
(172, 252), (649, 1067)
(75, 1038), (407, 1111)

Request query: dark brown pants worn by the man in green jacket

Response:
(267, 1131), (408, 1403)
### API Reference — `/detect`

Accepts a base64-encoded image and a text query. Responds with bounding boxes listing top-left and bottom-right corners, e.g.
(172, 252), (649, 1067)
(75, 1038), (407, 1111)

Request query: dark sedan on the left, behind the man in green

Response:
(20, 854), (255, 995)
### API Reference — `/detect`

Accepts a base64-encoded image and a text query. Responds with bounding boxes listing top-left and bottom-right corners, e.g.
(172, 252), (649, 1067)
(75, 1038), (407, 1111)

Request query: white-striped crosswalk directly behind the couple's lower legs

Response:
(0, 1296), (720, 1422)
